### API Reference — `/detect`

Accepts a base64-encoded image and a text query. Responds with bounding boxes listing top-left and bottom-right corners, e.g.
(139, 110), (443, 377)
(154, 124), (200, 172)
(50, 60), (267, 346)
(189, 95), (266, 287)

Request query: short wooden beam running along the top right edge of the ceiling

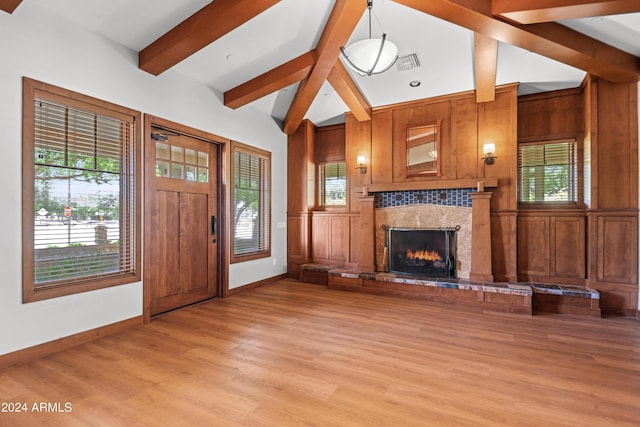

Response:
(491, 0), (640, 24)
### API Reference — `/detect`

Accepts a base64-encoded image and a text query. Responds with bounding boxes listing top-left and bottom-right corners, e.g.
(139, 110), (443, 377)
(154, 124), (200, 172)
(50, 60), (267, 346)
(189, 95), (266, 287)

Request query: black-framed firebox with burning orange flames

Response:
(383, 225), (460, 277)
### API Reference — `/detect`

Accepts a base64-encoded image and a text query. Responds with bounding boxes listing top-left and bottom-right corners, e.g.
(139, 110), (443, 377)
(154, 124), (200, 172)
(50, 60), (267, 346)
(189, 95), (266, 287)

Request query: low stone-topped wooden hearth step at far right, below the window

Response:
(530, 283), (601, 317)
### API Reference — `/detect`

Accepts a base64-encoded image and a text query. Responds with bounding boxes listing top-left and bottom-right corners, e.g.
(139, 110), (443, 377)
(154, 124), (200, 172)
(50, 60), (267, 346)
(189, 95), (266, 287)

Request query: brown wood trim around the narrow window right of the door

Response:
(229, 141), (273, 264)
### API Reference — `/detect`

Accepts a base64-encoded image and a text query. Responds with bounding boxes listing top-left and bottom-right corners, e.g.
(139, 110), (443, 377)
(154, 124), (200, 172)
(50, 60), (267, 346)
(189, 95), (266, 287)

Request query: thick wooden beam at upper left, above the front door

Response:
(138, 0), (279, 76)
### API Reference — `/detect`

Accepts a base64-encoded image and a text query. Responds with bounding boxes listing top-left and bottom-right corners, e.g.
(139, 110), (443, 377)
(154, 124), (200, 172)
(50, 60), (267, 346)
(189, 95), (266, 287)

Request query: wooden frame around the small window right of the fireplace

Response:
(516, 137), (584, 209)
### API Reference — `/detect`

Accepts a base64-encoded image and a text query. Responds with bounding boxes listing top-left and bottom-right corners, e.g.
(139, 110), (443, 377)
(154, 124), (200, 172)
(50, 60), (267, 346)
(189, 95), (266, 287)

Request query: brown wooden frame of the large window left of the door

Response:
(22, 77), (142, 303)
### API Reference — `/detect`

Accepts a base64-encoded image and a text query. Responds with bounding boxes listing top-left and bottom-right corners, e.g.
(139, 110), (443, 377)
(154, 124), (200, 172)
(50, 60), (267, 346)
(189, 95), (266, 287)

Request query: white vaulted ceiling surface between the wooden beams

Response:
(26, 0), (640, 125)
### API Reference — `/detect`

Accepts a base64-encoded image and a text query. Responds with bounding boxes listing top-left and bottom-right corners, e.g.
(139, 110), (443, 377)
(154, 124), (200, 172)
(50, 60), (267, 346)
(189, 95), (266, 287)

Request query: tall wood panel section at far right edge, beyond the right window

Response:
(585, 79), (638, 315)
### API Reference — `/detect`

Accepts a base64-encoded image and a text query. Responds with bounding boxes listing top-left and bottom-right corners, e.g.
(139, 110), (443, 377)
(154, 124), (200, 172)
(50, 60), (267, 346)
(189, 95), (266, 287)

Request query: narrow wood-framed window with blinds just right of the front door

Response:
(231, 143), (271, 262)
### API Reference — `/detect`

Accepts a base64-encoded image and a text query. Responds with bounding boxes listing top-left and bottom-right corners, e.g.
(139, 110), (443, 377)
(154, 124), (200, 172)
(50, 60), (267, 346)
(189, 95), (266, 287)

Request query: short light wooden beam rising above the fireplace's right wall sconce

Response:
(473, 33), (498, 102)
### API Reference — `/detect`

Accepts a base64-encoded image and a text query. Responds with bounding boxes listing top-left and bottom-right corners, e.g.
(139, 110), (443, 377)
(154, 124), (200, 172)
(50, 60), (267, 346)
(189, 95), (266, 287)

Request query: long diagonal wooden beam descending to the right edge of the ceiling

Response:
(394, 0), (640, 83)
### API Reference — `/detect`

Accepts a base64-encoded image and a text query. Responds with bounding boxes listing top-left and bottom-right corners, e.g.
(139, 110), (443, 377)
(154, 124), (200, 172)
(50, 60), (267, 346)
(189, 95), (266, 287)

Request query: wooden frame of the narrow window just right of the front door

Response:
(229, 141), (273, 264)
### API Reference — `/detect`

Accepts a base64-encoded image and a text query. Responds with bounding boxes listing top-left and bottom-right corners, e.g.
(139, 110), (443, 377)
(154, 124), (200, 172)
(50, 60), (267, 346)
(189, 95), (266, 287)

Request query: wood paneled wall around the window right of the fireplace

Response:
(517, 78), (638, 315)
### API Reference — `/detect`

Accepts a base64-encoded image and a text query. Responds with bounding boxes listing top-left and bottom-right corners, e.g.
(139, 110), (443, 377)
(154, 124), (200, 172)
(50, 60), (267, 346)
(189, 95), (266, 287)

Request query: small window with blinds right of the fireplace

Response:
(518, 141), (578, 203)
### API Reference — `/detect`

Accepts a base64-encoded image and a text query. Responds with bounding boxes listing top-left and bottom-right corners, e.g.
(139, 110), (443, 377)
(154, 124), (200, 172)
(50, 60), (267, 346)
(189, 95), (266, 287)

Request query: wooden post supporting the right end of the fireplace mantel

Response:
(469, 192), (493, 282)
